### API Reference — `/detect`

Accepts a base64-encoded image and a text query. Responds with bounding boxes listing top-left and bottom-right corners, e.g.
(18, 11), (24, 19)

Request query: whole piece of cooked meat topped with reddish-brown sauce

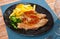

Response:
(17, 11), (48, 30)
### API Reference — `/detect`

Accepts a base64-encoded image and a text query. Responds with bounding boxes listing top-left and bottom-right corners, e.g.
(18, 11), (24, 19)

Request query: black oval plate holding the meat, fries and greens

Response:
(3, 3), (54, 36)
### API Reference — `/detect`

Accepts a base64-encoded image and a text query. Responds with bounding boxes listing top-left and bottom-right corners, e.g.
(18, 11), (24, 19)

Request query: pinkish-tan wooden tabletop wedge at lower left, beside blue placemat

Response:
(0, 8), (8, 39)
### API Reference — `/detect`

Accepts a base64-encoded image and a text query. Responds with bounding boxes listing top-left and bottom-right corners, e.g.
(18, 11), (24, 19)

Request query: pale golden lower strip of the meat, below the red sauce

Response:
(18, 19), (48, 30)
